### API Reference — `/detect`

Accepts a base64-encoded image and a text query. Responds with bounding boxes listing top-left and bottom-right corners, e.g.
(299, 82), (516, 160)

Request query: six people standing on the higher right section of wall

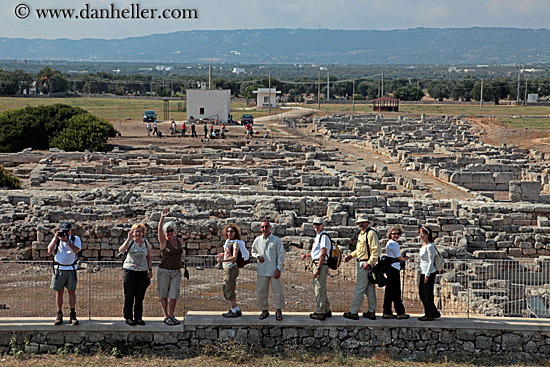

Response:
(218, 215), (441, 321)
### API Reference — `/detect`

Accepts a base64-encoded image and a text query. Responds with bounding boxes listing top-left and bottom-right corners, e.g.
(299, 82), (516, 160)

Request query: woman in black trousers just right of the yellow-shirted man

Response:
(382, 226), (410, 320)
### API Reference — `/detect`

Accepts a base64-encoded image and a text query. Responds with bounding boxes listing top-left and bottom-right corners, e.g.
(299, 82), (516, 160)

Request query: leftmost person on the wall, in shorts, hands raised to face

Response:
(48, 222), (82, 325)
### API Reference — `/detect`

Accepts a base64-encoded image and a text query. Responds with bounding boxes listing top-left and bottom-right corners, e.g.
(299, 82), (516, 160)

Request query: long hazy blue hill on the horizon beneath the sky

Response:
(0, 28), (550, 65)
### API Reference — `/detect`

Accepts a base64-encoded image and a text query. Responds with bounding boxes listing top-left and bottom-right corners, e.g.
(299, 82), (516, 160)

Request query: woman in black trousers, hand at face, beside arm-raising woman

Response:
(118, 223), (153, 326)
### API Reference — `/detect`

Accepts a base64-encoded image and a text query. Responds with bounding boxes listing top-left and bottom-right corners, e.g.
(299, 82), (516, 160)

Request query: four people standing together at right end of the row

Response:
(308, 215), (441, 321)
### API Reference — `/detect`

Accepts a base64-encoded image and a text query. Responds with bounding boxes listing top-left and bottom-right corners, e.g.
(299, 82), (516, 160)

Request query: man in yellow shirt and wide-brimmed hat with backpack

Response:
(344, 214), (380, 320)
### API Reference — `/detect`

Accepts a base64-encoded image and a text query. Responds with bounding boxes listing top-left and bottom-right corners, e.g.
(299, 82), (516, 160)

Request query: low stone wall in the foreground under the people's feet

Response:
(0, 315), (550, 361)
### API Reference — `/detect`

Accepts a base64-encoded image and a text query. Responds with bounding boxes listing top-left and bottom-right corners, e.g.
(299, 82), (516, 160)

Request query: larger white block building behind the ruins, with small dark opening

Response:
(186, 89), (231, 122)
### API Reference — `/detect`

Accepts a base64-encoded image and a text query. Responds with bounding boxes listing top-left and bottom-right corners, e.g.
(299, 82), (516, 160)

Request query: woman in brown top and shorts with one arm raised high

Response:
(157, 209), (183, 325)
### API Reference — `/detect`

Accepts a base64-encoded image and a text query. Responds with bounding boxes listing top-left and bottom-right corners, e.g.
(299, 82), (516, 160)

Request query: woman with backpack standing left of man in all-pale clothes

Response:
(218, 223), (250, 317)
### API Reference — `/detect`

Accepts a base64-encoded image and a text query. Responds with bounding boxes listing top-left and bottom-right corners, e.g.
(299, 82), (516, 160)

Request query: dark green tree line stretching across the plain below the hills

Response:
(0, 66), (550, 103)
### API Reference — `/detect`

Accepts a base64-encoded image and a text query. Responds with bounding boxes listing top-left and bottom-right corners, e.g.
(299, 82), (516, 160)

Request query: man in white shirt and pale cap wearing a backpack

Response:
(302, 217), (332, 320)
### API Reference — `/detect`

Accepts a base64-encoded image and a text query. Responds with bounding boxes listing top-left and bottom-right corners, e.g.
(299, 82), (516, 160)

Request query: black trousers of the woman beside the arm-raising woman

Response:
(124, 269), (151, 320)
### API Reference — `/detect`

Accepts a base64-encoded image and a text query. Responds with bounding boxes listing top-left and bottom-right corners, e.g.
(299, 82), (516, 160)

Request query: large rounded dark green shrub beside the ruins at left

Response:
(0, 104), (116, 152)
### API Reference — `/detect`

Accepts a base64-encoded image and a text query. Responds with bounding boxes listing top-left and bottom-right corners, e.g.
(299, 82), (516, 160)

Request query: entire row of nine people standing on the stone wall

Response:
(48, 214), (441, 326)
